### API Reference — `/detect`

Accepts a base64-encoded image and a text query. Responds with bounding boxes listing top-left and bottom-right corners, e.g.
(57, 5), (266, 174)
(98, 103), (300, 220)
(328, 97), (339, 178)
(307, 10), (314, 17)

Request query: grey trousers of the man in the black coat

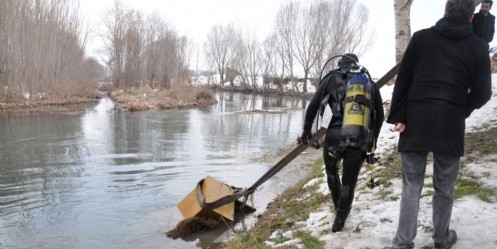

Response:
(392, 152), (460, 248)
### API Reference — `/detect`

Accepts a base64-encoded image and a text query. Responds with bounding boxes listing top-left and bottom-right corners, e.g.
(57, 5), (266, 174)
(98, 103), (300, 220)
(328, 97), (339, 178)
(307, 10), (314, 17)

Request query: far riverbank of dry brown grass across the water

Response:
(0, 77), (313, 111)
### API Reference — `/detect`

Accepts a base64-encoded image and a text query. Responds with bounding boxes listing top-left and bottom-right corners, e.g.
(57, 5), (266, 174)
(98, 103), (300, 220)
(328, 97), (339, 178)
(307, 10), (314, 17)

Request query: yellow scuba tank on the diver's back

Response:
(340, 73), (373, 151)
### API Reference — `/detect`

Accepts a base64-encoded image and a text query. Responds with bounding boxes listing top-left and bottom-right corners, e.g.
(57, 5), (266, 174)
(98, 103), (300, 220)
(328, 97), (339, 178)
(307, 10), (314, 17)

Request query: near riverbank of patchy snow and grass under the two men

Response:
(224, 75), (497, 249)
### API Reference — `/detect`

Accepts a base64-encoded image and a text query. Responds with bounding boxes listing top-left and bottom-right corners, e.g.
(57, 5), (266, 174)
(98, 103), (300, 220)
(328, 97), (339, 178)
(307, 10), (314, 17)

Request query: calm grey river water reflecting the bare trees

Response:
(0, 92), (306, 249)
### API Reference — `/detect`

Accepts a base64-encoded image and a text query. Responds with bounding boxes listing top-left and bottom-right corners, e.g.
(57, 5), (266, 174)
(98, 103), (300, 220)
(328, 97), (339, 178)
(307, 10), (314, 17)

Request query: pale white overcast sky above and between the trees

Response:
(80, 0), (497, 77)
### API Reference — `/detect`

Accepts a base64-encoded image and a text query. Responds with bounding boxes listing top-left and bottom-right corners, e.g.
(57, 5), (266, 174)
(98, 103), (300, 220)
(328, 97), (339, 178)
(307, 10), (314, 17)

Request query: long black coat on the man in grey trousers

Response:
(387, 18), (492, 156)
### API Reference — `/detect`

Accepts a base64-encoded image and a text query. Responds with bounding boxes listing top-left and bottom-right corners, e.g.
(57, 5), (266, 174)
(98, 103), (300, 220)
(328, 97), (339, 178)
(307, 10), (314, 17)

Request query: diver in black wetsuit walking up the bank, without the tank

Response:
(302, 54), (384, 232)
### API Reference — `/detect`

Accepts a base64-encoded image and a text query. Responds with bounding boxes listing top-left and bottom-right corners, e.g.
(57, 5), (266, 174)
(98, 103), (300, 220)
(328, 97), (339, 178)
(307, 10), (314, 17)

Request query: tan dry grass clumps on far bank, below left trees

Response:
(0, 80), (217, 111)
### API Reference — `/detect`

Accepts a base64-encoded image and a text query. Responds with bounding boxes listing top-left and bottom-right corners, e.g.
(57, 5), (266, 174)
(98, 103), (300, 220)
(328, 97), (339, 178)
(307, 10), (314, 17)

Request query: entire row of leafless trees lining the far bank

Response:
(0, 0), (369, 102)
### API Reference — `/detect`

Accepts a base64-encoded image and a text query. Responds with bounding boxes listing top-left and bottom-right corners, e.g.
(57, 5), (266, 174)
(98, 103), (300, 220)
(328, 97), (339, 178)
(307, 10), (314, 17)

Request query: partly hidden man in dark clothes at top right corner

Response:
(472, 0), (495, 43)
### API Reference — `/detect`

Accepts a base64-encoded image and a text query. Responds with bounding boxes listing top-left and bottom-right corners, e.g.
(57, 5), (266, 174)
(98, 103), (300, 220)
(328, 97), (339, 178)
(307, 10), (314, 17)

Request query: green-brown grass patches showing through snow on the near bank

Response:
(224, 128), (497, 249)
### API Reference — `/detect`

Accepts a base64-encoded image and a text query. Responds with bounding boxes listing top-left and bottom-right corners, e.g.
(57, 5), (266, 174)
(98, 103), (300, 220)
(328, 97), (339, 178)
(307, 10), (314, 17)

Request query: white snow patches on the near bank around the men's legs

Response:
(268, 74), (497, 249)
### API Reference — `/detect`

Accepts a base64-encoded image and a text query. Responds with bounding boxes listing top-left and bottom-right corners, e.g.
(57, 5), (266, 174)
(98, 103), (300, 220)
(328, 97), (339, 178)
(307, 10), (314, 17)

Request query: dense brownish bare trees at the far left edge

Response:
(0, 0), (88, 101)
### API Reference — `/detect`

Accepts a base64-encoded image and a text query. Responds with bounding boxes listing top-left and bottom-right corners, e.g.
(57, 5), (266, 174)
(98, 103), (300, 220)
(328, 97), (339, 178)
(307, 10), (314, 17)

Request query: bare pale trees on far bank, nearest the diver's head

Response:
(204, 0), (369, 92)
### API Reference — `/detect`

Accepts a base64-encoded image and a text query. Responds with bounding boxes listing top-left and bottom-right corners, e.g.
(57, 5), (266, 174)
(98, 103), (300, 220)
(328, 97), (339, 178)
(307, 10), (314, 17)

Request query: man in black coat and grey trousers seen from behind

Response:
(386, 0), (492, 248)
